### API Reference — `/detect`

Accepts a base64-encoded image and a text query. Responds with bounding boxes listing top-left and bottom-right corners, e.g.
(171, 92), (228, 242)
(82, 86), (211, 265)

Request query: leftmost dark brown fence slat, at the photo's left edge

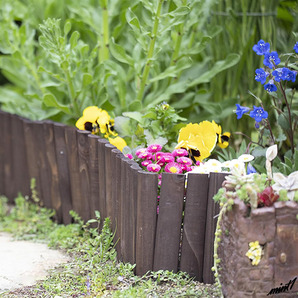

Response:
(2, 113), (15, 203)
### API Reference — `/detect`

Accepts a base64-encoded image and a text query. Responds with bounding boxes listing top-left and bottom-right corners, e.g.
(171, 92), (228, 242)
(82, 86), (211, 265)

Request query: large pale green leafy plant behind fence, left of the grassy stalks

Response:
(0, 0), (238, 124)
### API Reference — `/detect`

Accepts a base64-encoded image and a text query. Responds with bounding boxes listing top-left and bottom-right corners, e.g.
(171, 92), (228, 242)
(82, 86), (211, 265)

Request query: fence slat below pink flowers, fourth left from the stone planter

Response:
(136, 171), (157, 275)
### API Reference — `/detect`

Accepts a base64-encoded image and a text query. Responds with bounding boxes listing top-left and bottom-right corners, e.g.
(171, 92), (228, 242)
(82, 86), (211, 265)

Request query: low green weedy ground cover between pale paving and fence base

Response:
(0, 190), (219, 297)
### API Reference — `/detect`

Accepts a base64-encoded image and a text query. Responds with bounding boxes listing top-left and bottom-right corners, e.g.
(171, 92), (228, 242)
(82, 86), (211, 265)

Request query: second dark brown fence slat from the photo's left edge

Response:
(11, 115), (30, 197)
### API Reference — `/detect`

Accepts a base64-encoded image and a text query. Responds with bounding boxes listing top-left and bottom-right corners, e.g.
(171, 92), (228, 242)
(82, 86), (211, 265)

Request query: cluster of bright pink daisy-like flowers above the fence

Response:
(136, 144), (193, 177)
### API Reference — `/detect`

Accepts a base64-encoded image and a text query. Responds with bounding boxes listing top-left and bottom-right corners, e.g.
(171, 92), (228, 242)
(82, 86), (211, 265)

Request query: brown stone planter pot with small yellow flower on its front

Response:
(218, 199), (298, 298)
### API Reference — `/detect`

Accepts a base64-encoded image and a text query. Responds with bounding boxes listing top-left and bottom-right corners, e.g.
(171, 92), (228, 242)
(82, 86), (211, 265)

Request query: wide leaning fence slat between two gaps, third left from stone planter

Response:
(153, 173), (185, 272)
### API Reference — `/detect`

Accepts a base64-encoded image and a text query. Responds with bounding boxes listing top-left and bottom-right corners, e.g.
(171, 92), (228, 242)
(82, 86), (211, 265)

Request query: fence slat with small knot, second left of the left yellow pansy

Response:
(54, 123), (72, 224)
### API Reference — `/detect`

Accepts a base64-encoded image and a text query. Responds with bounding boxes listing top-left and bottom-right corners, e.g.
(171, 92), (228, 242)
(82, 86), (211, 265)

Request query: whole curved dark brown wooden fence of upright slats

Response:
(0, 111), (225, 283)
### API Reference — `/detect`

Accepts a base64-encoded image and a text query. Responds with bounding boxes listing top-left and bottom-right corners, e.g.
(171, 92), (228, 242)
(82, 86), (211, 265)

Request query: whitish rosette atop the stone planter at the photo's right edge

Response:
(272, 171), (298, 201)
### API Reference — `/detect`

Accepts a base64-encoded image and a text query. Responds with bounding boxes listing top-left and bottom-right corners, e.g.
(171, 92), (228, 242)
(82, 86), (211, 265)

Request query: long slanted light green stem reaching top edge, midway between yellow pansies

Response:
(137, 0), (164, 102)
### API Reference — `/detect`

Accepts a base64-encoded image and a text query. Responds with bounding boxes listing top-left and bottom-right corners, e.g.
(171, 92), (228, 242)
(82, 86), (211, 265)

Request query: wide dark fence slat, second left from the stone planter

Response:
(180, 173), (209, 282)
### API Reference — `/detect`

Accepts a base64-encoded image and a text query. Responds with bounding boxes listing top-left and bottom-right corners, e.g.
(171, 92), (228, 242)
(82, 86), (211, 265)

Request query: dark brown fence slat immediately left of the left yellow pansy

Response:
(64, 127), (82, 214)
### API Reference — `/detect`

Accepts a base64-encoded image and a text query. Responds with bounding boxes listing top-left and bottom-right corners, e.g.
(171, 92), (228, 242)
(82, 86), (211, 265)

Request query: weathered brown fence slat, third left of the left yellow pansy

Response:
(42, 120), (63, 223)
